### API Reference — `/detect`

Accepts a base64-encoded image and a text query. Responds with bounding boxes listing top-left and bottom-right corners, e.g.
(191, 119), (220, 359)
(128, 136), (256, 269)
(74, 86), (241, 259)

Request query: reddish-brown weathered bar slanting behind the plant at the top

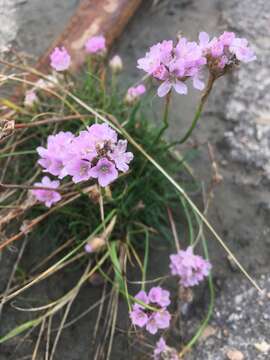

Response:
(37, 0), (142, 73)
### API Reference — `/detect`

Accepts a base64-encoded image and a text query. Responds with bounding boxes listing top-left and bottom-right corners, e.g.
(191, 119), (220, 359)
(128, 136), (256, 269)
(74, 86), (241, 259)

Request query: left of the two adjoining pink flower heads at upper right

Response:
(138, 37), (206, 97)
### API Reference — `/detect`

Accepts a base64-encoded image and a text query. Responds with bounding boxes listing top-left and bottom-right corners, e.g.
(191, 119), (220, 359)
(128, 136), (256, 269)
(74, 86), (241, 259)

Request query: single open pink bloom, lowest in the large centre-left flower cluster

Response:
(89, 158), (118, 187)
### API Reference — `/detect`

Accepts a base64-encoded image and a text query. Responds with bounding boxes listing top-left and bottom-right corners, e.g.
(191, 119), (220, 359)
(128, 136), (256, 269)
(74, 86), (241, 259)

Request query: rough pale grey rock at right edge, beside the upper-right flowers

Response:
(222, 0), (270, 180)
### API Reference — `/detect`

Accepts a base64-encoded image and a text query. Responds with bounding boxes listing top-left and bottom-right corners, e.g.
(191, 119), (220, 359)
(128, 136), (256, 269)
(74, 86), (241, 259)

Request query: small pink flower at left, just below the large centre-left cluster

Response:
(32, 176), (61, 207)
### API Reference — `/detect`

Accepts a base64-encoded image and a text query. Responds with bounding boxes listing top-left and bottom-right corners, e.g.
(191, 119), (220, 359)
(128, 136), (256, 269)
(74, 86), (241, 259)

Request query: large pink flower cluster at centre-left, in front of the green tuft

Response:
(37, 124), (133, 187)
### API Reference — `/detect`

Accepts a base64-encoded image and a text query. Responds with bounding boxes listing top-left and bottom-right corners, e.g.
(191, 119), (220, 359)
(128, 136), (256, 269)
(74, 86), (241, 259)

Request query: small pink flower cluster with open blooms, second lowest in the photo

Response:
(129, 287), (171, 334)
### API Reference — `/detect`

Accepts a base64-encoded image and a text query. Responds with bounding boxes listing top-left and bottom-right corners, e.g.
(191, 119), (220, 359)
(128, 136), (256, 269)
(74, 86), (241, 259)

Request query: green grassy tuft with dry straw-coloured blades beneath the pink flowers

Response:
(0, 59), (200, 358)
